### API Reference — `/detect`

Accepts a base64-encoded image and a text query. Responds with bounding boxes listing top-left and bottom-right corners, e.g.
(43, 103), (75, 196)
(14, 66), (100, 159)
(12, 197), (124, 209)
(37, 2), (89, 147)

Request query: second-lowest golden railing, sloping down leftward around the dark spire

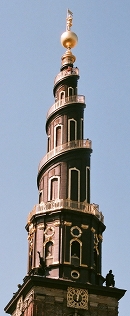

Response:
(38, 139), (92, 171)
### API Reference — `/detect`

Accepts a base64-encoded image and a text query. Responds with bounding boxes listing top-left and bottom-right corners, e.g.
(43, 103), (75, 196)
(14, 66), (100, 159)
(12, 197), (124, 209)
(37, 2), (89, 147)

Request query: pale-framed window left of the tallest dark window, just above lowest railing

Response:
(48, 176), (60, 201)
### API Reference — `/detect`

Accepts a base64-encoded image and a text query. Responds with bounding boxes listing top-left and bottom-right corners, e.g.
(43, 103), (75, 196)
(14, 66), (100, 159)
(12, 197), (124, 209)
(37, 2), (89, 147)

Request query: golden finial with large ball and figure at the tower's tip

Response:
(61, 9), (78, 67)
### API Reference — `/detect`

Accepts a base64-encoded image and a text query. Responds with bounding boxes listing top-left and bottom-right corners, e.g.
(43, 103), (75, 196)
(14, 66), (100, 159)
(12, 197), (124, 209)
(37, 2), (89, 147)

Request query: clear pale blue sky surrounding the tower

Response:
(0, 0), (130, 316)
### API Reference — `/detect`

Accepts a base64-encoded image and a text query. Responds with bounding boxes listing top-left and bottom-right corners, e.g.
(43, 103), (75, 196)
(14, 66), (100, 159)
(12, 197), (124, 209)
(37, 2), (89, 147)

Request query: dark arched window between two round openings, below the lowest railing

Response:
(70, 240), (81, 267)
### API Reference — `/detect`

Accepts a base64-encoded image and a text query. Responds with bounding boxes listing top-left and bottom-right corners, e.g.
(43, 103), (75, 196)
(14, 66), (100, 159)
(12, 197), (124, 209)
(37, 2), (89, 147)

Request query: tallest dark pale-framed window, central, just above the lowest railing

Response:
(68, 168), (80, 202)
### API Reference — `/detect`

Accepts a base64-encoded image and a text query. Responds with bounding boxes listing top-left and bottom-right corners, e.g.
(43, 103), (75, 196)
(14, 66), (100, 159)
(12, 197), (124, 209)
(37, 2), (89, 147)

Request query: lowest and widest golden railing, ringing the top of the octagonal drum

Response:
(27, 199), (104, 223)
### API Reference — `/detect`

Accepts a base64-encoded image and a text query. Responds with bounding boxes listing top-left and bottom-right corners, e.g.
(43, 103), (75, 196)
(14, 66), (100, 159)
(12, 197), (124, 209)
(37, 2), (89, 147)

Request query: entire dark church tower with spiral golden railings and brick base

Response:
(5, 10), (125, 316)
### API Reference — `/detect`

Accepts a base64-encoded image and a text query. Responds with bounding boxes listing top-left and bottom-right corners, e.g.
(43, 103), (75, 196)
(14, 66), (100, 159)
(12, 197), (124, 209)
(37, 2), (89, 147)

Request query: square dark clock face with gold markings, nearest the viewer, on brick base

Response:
(67, 287), (88, 309)
